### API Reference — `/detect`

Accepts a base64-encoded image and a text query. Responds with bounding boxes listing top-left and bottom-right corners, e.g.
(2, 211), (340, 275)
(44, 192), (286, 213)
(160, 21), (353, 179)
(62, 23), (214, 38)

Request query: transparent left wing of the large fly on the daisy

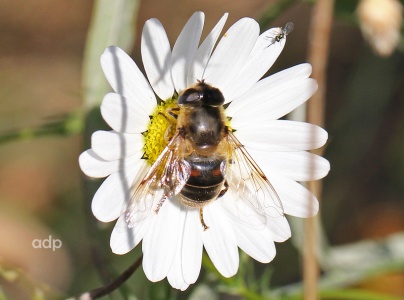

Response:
(125, 133), (191, 227)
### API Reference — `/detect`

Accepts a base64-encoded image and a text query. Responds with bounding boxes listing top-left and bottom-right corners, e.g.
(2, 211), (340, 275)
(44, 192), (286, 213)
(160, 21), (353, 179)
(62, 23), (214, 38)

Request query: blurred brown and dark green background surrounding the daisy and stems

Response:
(0, 0), (404, 299)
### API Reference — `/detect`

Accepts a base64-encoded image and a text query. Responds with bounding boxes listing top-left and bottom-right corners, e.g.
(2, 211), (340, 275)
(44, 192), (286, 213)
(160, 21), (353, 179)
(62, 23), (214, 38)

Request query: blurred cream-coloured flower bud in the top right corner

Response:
(357, 0), (403, 56)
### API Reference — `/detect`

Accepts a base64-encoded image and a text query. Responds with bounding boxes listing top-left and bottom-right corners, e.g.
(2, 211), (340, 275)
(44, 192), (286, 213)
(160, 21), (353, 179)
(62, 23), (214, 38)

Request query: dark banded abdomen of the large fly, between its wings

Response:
(180, 155), (225, 207)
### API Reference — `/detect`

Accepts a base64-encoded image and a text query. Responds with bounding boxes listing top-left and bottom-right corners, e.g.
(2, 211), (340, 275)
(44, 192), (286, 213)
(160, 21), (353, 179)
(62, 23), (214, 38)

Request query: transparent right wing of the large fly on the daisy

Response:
(226, 132), (284, 218)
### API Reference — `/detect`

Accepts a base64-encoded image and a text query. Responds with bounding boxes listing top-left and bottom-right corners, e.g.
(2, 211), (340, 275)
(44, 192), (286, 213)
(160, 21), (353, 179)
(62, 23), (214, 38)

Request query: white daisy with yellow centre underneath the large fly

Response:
(79, 12), (329, 290)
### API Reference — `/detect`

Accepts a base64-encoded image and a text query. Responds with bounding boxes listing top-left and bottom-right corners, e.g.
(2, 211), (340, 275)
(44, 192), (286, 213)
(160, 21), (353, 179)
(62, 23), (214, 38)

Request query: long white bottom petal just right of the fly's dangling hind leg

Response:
(202, 201), (239, 277)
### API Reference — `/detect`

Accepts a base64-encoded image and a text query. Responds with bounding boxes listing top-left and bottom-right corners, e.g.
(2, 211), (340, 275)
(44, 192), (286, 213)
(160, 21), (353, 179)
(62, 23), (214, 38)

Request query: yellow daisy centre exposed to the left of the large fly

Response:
(143, 99), (178, 165)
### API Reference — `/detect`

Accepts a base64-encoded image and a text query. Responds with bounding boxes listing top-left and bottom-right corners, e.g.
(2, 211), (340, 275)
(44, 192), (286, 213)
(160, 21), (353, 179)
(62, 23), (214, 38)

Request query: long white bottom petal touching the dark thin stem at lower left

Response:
(142, 199), (181, 282)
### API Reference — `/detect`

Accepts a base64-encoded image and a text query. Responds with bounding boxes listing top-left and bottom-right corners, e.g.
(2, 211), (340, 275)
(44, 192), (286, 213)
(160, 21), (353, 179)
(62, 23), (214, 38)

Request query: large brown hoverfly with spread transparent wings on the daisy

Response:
(126, 80), (283, 230)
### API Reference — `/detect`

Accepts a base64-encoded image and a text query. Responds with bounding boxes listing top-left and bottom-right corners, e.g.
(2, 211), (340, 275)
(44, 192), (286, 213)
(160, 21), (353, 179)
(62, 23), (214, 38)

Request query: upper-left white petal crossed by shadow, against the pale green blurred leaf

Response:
(101, 46), (156, 115)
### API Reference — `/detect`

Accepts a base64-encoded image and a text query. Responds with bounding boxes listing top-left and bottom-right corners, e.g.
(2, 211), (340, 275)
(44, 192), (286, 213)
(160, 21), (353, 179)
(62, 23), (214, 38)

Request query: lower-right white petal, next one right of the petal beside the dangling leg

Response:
(233, 223), (276, 263)
